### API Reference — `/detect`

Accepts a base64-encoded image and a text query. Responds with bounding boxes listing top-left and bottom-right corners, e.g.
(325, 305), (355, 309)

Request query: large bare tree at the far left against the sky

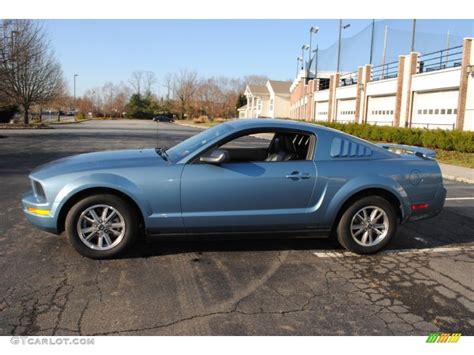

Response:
(0, 20), (63, 124)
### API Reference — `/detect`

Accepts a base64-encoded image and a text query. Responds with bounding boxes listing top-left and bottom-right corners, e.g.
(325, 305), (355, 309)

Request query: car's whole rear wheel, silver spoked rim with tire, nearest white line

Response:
(337, 196), (398, 254)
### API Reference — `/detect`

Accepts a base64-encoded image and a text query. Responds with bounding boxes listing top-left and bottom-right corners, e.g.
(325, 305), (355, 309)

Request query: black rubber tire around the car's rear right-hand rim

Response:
(337, 196), (398, 254)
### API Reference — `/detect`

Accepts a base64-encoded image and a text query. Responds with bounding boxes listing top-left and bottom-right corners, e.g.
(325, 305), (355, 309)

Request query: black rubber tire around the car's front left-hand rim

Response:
(65, 194), (139, 259)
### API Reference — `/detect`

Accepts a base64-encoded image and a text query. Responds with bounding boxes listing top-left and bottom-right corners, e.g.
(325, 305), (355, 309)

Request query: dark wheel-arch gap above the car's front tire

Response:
(57, 186), (145, 233)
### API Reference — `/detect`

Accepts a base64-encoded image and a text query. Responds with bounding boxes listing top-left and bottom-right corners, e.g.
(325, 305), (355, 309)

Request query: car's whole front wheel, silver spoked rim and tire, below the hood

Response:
(65, 194), (138, 259)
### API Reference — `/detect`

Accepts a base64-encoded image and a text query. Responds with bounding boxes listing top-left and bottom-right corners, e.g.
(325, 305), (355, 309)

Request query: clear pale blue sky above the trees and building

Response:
(43, 19), (474, 96)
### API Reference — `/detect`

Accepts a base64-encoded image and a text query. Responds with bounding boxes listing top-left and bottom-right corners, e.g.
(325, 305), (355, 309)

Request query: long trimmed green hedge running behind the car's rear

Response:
(314, 122), (474, 153)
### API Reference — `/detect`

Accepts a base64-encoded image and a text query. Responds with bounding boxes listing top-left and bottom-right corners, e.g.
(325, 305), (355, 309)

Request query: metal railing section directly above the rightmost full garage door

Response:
(418, 46), (462, 73)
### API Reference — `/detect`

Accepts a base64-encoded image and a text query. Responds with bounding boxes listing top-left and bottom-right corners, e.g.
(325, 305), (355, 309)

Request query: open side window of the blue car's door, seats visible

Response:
(213, 131), (314, 163)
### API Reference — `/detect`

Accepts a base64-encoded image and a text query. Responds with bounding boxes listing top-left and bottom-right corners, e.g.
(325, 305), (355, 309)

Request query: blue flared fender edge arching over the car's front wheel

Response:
(51, 173), (152, 217)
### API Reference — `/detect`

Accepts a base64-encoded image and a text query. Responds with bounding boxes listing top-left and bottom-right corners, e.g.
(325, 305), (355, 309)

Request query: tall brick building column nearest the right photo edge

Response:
(456, 38), (474, 131)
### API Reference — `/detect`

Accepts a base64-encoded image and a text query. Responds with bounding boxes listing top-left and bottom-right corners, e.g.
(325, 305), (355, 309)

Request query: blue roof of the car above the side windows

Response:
(226, 118), (332, 132)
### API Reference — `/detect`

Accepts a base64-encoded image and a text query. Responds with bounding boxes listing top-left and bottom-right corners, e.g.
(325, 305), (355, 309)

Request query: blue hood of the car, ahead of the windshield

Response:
(30, 148), (167, 179)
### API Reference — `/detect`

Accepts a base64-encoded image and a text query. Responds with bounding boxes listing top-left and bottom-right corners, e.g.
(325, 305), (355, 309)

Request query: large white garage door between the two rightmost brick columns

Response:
(411, 90), (459, 129)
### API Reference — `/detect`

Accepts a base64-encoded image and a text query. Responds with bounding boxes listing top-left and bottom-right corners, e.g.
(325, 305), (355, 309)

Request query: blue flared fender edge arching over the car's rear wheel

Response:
(325, 175), (410, 225)
